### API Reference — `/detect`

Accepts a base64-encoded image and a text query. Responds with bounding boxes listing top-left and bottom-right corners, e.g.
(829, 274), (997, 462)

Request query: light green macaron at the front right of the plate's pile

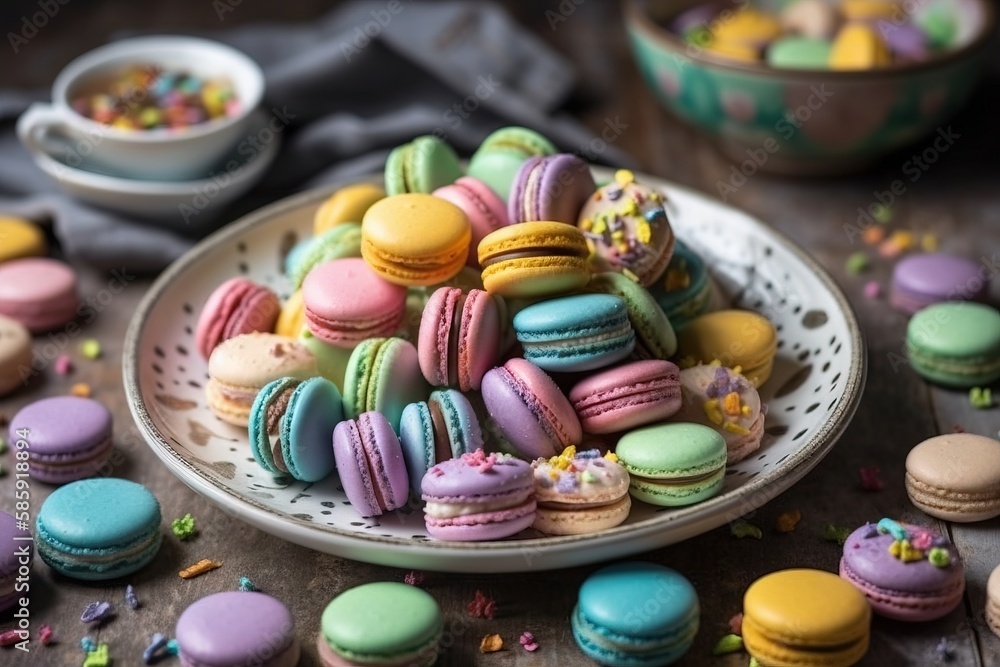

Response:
(615, 423), (726, 507)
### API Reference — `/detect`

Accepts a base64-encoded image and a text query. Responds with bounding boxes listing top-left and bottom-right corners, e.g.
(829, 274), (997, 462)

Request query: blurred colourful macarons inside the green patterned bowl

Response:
(670, 0), (960, 70)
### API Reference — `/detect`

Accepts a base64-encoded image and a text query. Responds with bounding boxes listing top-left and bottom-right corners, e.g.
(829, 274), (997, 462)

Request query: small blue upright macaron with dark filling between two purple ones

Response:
(399, 389), (483, 495)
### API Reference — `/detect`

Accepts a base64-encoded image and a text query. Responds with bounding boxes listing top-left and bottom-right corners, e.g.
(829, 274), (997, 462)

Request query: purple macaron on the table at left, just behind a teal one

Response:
(10, 396), (113, 484)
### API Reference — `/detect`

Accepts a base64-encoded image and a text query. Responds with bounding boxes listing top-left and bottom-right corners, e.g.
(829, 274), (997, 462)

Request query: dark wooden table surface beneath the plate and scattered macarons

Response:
(0, 0), (1000, 667)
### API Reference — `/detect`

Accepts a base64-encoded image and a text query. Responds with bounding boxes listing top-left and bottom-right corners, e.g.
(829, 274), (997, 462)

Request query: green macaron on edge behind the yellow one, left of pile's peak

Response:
(385, 134), (462, 195)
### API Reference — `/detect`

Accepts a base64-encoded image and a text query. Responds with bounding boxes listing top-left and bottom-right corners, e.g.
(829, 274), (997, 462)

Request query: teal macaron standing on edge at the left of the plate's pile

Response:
(249, 377), (344, 482)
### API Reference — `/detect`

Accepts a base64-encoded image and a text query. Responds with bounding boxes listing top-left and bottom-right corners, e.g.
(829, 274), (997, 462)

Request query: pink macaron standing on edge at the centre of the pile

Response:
(417, 287), (503, 391)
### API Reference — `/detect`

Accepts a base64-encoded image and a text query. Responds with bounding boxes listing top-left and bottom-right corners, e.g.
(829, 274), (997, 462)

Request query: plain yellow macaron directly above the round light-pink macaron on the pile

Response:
(361, 193), (472, 287)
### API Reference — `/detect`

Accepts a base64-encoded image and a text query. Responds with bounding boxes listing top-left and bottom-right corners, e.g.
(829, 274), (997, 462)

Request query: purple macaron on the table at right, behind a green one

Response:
(889, 253), (989, 315)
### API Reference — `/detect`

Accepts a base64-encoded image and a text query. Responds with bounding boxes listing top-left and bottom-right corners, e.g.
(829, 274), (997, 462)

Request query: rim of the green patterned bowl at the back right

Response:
(622, 0), (997, 83)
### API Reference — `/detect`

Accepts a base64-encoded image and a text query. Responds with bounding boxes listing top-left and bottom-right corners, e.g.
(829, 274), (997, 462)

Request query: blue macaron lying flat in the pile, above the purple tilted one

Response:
(513, 294), (635, 373)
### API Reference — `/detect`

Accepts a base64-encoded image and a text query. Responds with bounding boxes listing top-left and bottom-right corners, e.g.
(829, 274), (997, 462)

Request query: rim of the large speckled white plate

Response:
(122, 167), (868, 572)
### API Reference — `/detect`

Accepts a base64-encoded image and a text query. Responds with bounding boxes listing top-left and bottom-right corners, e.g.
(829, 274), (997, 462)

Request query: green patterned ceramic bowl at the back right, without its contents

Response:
(624, 0), (995, 176)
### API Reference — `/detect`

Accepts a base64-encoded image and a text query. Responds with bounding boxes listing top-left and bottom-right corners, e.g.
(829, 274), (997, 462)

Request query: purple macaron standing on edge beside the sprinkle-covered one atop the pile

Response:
(507, 153), (597, 225)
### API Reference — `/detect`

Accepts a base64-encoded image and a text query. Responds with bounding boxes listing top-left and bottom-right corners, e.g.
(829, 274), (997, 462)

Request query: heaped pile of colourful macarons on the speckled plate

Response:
(195, 127), (777, 540)
